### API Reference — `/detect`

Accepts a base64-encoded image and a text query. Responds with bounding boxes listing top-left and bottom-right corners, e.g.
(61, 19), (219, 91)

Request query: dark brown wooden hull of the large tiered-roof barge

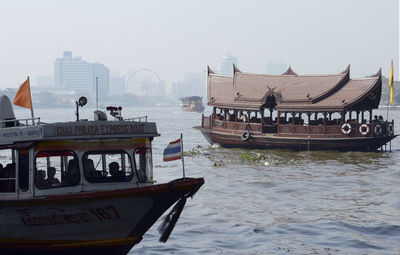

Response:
(195, 127), (397, 151)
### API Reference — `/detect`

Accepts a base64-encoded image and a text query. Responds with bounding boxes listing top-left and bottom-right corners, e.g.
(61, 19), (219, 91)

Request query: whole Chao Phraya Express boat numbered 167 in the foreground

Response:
(0, 96), (204, 255)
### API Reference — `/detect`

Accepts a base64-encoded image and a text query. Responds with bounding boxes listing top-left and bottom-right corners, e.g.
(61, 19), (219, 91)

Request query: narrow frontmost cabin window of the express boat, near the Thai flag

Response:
(134, 148), (152, 183)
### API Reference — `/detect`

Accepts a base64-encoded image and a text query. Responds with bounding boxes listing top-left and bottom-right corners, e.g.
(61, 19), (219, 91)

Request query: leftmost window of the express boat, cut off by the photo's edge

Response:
(0, 149), (15, 192)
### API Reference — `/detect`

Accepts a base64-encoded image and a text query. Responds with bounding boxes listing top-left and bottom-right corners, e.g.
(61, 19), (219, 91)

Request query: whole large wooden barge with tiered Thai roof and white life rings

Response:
(194, 66), (397, 151)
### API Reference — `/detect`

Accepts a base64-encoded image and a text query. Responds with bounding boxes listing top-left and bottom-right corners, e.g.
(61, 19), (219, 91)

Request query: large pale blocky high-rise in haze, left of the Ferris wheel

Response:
(54, 51), (110, 97)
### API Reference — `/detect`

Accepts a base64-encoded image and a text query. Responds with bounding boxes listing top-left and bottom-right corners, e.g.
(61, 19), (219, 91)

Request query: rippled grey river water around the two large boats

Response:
(16, 106), (400, 254)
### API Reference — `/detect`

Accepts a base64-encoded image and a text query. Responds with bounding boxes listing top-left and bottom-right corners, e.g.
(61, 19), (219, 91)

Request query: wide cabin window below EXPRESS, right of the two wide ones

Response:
(83, 151), (133, 183)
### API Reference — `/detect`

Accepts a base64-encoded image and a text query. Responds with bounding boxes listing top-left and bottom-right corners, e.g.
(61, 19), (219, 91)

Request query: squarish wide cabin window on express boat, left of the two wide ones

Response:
(35, 151), (81, 189)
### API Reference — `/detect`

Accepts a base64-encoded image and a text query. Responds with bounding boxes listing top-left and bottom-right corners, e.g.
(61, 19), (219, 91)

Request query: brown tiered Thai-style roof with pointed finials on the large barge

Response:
(207, 65), (382, 112)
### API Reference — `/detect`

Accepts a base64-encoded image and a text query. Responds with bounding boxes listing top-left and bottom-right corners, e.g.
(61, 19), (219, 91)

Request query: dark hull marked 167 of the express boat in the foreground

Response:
(0, 178), (204, 255)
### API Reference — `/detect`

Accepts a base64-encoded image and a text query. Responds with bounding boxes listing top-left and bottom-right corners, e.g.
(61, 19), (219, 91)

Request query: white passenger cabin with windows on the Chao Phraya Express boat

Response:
(0, 96), (159, 200)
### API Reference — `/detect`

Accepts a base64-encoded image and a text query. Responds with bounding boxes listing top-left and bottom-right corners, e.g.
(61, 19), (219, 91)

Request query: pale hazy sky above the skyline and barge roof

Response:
(0, 0), (399, 88)
